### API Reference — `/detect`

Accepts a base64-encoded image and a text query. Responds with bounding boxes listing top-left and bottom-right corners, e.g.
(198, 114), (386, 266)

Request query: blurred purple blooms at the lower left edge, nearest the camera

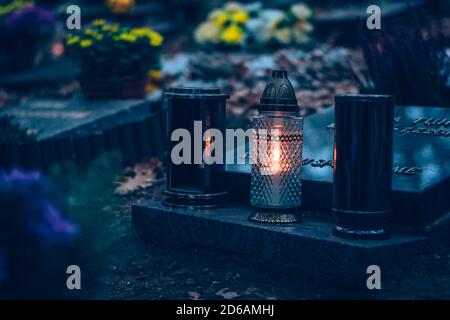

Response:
(0, 169), (78, 285)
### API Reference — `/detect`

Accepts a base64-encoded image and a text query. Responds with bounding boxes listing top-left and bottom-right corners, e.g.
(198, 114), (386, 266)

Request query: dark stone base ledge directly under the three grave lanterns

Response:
(132, 202), (430, 284)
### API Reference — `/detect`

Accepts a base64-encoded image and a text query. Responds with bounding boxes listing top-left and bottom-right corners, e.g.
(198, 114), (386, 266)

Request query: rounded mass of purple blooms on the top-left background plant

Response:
(5, 5), (56, 36)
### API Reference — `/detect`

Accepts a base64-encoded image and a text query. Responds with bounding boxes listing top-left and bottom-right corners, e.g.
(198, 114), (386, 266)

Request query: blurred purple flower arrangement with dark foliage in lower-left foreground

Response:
(0, 169), (79, 298)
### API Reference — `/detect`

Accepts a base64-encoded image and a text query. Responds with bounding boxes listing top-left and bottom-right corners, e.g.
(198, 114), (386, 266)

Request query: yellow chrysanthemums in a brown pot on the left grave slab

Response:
(66, 20), (163, 99)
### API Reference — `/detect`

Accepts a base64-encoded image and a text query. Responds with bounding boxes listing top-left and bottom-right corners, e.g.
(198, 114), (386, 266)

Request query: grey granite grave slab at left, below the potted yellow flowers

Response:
(0, 92), (166, 170)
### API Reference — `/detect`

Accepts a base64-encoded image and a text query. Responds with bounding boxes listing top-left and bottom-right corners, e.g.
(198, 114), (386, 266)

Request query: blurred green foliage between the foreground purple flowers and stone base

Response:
(47, 153), (139, 297)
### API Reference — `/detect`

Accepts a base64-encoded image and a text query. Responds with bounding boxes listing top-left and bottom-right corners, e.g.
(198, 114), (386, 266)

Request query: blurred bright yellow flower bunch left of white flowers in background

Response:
(194, 2), (249, 48)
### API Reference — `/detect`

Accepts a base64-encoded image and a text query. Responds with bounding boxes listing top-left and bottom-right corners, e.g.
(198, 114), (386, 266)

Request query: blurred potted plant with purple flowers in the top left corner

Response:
(0, 1), (56, 70)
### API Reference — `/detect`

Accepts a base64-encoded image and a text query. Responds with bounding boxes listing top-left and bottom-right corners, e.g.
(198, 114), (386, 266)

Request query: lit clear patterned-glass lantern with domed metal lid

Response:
(249, 70), (303, 223)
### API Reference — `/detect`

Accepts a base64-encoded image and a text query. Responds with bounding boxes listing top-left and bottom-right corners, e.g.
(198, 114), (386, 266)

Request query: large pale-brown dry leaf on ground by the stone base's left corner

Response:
(115, 158), (162, 196)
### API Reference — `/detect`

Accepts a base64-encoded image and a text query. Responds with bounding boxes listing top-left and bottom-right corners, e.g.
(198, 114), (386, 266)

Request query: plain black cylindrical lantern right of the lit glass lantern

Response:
(333, 94), (394, 239)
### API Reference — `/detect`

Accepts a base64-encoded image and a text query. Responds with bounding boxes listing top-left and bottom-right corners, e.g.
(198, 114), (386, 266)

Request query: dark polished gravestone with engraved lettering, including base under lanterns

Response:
(132, 107), (450, 281)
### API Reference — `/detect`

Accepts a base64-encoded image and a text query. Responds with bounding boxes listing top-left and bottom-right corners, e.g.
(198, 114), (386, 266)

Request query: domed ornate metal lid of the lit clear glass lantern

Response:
(258, 70), (298, 113)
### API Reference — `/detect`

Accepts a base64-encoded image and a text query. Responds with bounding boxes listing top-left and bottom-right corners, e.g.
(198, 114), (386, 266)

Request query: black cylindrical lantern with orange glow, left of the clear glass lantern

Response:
(163, 87), (229, 208)
